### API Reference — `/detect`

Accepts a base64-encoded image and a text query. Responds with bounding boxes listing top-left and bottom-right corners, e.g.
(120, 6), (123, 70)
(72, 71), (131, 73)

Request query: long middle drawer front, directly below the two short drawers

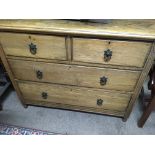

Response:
(9, 59), (140, 91)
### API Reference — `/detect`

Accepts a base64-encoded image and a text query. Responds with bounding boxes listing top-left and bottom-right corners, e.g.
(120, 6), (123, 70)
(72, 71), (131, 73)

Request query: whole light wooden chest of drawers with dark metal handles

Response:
(0, 20), (155, 120)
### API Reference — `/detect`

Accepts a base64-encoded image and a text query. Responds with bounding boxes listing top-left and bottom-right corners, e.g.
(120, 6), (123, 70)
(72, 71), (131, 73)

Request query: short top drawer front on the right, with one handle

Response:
(73, 38), (151, 67)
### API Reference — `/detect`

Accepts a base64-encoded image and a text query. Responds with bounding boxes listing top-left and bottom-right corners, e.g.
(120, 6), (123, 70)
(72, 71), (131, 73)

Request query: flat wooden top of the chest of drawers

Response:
(0, 19), (155, 40)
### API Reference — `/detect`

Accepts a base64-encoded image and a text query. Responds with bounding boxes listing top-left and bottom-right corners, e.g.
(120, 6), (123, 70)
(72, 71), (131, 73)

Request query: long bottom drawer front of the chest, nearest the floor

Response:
(18, 82), (130, 111)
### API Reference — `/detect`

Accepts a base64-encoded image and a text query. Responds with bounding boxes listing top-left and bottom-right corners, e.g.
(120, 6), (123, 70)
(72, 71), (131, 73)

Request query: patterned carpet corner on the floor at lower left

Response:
(0, 123), (57, 135)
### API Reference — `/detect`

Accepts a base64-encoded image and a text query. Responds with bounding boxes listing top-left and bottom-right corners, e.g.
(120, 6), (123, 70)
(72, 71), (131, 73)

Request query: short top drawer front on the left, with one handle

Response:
(0, 33), (66, 60)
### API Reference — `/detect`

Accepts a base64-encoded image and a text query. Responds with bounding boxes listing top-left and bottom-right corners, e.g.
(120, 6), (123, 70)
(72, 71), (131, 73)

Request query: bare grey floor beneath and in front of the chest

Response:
(0, 90), (155, 135)
